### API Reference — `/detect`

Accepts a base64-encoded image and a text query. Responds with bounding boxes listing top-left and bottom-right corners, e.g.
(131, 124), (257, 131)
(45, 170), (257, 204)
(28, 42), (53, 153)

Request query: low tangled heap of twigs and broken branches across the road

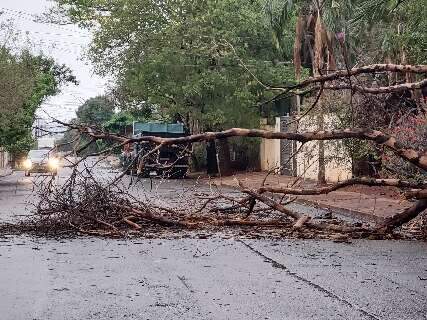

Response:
(0, 169), (425, 241)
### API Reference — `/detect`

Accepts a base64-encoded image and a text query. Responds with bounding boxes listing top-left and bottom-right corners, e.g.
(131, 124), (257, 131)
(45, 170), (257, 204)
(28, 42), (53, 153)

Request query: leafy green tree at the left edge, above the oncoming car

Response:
(0, 46), (76, 153)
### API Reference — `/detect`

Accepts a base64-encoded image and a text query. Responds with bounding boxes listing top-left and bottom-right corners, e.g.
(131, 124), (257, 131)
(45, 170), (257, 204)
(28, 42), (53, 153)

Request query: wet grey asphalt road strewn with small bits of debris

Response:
(0, 165), (427, 320)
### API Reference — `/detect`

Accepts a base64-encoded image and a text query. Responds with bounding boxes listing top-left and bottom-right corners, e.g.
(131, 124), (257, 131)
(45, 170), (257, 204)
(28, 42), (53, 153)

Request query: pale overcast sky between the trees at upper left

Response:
(0, 0), (106, 121)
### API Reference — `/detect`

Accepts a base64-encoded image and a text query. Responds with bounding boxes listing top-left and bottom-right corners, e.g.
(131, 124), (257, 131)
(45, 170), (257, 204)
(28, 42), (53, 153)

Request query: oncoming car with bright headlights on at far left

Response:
(23, 149), (59, 177)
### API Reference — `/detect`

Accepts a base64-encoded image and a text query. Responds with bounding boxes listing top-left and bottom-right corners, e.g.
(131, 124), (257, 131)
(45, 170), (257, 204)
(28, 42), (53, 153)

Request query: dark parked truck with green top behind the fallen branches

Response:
(122, 123), (189, 178)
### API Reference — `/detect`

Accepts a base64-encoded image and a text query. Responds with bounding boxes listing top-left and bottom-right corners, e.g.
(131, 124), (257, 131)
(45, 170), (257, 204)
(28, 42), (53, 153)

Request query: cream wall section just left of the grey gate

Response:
(260, 118), (280, 171)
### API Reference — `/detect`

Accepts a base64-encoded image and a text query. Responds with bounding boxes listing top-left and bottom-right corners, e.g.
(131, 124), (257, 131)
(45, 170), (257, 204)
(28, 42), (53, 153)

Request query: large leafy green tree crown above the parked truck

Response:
(51, 0), (293, 129)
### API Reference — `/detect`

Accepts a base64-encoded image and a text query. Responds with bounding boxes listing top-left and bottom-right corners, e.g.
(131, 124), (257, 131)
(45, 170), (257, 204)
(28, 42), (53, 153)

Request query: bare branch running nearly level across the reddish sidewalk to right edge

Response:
(258, 178), (427, 195)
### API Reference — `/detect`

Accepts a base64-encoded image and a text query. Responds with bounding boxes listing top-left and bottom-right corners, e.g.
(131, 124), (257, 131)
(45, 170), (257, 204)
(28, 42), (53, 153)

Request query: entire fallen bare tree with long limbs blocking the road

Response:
(10, 61), (427, 237)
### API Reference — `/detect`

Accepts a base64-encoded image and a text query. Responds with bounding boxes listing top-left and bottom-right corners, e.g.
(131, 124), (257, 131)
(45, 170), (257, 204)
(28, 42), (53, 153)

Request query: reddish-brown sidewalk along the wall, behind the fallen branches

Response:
(210, 172), (411, 222)
